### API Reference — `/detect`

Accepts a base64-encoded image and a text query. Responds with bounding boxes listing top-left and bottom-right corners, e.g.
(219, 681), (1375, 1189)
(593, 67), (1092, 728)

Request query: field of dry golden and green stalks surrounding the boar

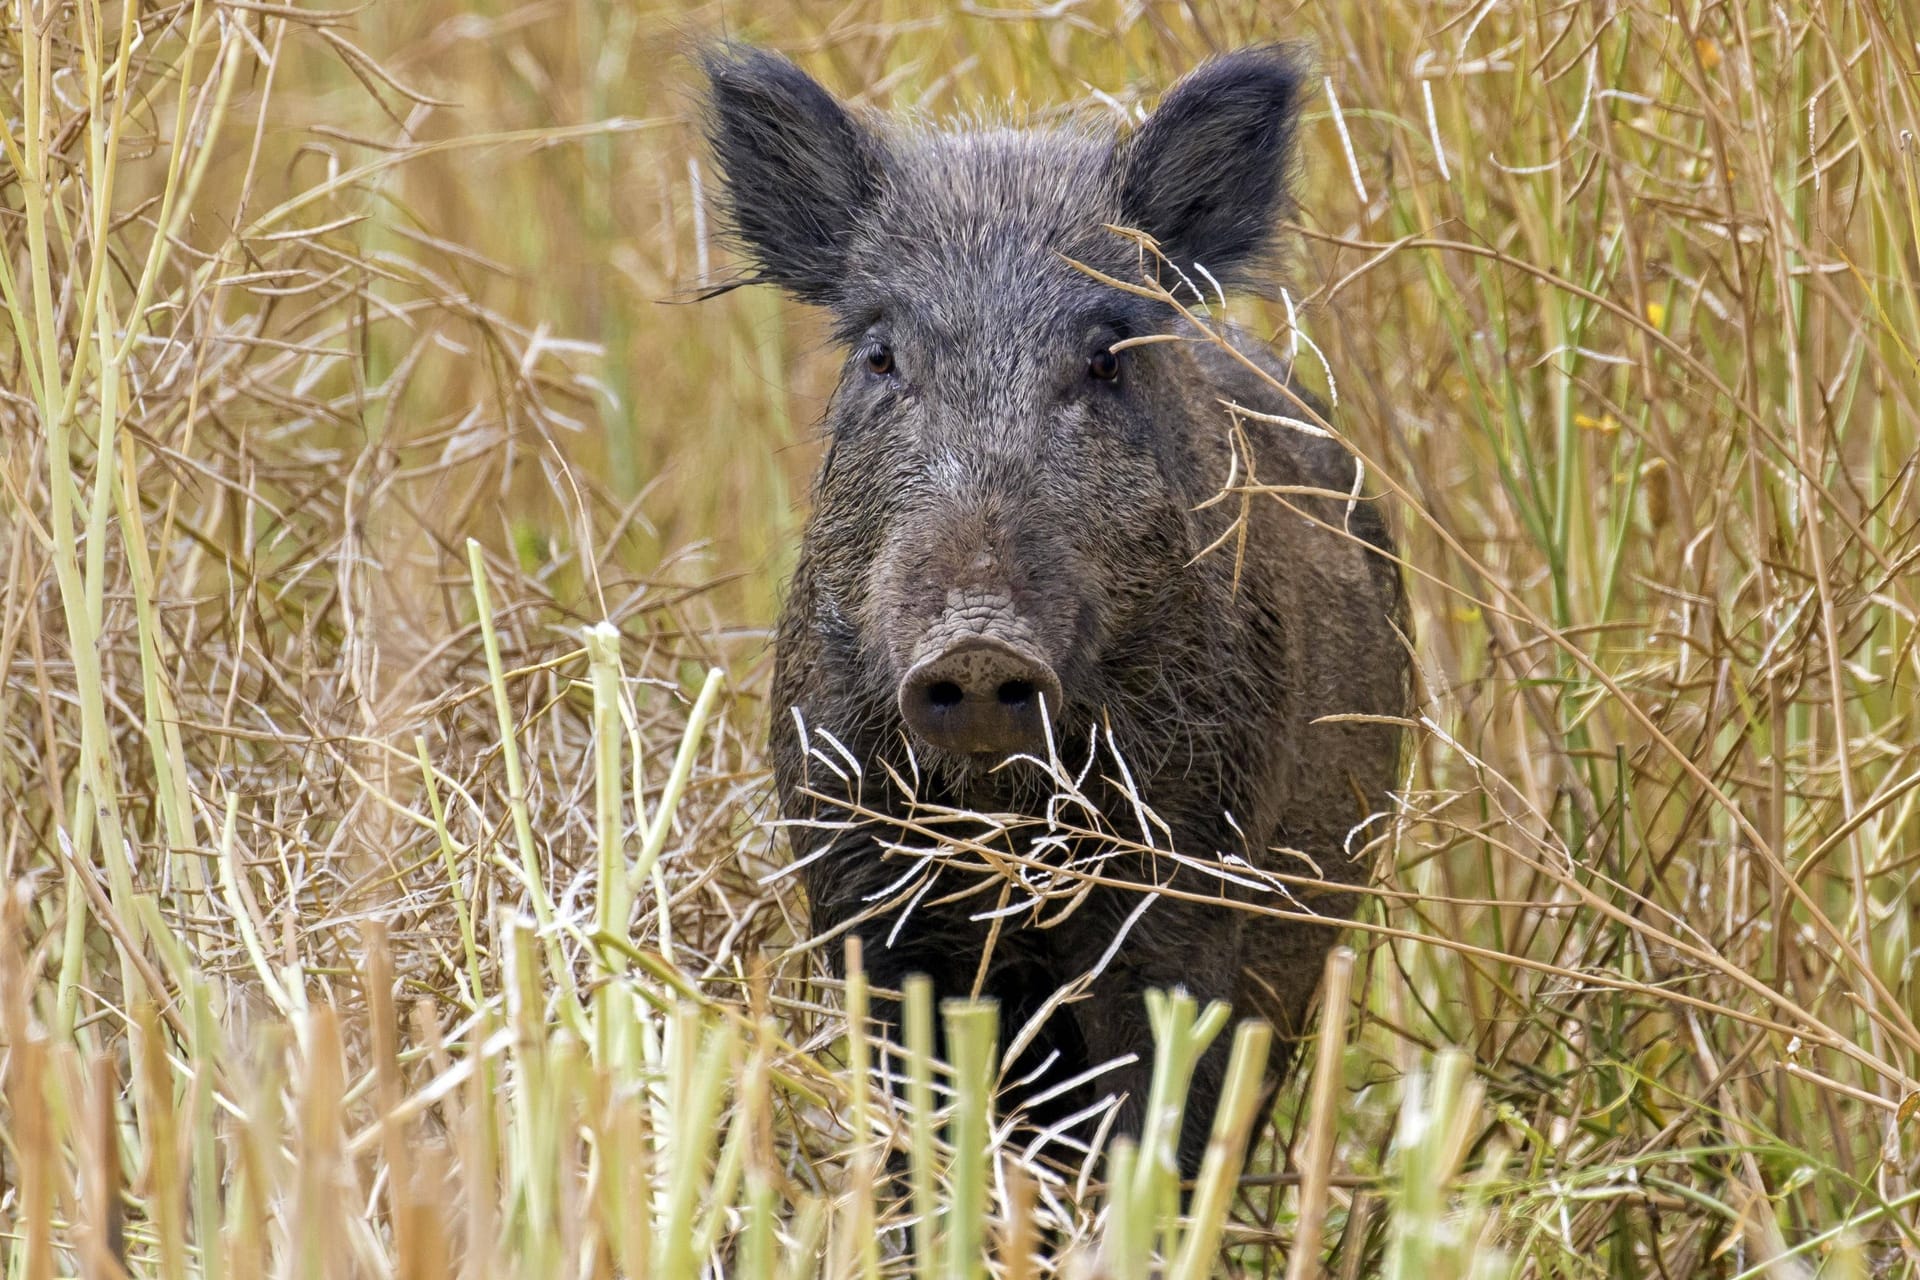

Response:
(0, 0), (1920, 1280)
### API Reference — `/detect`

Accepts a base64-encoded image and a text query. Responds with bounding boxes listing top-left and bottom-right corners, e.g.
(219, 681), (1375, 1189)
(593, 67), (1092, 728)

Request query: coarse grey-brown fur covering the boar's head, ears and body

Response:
(703, 46), (1409, 1171)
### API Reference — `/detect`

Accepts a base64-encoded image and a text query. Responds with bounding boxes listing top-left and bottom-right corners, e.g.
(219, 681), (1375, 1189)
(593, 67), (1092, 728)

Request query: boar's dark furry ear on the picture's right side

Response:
(1117, 44), (1306, 280)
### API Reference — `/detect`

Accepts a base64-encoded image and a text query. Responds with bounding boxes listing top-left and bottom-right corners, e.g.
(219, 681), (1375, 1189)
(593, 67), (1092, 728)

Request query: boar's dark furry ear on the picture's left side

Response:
(697, 44), (879, 303)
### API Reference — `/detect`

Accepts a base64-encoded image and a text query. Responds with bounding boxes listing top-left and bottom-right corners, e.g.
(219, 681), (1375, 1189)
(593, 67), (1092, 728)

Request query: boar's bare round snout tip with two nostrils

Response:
(900, 635), (1060, 756)
